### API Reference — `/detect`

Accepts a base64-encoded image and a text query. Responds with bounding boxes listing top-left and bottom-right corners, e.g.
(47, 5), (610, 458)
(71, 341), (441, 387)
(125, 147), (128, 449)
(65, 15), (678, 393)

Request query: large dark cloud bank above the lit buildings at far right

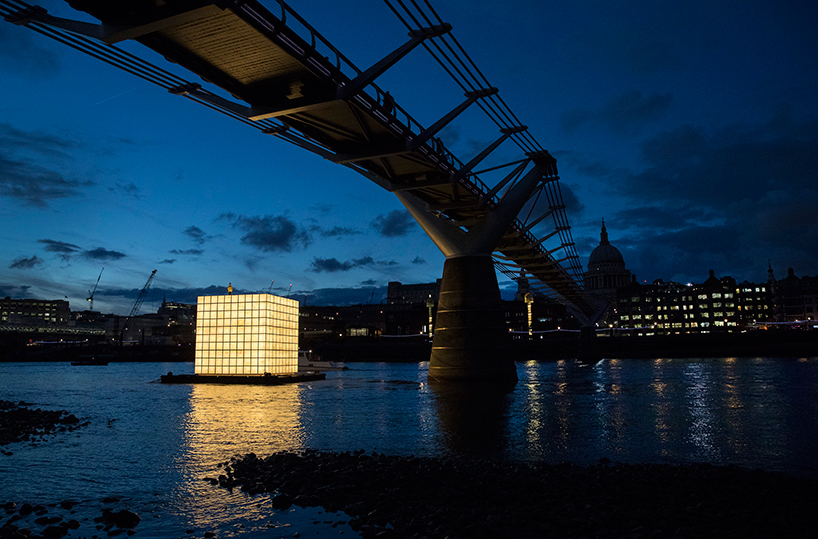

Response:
(576, 112), (818, 281)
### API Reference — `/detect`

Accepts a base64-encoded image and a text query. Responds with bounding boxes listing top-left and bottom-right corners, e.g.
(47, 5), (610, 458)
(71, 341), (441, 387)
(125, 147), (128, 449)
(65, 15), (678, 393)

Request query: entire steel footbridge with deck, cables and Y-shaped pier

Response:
(0, 0), (602, 381)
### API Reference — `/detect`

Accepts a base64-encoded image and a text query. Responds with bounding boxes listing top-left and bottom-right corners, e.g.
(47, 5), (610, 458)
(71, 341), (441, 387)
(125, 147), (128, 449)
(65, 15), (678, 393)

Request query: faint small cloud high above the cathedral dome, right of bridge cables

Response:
(560, 90), (673, 135)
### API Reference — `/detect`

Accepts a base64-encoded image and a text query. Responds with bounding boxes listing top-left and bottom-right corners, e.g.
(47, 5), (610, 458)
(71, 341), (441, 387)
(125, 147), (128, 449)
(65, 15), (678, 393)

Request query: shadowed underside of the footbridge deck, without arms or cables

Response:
(63, 0), (591, 312)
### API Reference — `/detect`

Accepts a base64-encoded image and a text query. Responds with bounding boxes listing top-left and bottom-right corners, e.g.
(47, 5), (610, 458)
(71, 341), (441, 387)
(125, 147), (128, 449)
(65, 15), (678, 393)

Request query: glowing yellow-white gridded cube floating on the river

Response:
(195, 294), (298, 376)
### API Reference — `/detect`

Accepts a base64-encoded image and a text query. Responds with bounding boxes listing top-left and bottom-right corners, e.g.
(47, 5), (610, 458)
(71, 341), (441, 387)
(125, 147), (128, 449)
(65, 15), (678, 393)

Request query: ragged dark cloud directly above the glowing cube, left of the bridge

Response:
(219, 212), (312, 252)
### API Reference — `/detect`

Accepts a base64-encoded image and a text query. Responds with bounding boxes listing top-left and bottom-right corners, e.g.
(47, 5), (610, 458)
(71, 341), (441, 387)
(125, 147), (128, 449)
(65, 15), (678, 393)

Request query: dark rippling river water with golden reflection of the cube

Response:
(0, 358), (818, 537)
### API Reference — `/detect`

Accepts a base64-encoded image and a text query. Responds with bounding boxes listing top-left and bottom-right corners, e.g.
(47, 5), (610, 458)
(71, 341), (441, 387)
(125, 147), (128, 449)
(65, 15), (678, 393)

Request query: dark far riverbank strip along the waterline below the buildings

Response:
(6, 330), (818, 363)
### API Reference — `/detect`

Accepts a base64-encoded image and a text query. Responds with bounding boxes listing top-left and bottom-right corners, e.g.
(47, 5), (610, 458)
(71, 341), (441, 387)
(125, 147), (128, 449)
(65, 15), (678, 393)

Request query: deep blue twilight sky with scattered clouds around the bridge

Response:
(0, 0), (818, 313)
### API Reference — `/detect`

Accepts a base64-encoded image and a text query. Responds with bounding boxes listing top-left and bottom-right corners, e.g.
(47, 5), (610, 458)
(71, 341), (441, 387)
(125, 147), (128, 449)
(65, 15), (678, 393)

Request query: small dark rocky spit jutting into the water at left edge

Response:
(0, 400), (88, 455)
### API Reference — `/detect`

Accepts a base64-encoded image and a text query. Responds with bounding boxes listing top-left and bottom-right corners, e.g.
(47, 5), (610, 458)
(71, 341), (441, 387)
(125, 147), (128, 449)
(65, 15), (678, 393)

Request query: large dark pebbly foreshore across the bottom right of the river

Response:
(209, 451), (818, 539)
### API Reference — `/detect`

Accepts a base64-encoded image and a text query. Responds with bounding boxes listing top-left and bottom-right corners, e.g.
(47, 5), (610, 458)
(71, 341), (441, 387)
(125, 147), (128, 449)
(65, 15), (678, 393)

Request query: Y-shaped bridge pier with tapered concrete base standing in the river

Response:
(396, 154), (554, 384)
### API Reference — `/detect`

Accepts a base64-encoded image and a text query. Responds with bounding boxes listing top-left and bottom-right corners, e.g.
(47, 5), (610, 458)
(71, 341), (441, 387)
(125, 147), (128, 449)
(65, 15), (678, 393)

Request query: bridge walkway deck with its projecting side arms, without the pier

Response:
(0, 0), (595, 316)
